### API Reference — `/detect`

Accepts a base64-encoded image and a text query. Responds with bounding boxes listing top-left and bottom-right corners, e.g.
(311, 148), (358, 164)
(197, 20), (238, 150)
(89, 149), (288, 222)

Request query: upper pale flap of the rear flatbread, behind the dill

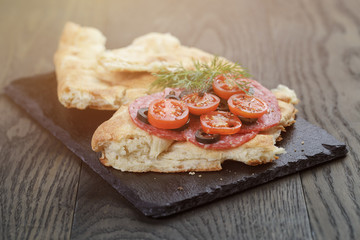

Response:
(99, 33), (213, 72)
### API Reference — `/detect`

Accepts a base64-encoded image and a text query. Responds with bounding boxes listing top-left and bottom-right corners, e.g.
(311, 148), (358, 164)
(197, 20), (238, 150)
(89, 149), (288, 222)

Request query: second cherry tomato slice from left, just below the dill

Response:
(181, 93), (220, 116)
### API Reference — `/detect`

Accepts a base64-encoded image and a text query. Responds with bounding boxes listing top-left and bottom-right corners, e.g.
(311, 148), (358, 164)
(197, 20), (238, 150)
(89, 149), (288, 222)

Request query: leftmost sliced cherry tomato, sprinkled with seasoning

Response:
(148, 99), (189, 129)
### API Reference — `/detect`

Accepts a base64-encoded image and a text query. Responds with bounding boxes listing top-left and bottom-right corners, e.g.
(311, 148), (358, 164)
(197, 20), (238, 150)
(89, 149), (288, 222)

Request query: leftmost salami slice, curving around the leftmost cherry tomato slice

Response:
(129, 91), (185, 141)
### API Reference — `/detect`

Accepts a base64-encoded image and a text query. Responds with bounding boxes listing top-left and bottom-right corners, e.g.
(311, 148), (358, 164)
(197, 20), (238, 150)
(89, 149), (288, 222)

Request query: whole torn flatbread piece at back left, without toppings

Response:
(54, 22), (217, 110)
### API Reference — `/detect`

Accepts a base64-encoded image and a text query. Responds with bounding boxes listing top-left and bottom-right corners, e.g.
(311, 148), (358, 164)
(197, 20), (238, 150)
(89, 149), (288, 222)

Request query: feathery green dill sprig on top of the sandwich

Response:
(151, 56), (250, 93)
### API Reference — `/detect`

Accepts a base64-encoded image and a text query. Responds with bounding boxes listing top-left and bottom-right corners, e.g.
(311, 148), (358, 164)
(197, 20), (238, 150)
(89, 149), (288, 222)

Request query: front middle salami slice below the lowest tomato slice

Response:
(184, 116), (257, 150)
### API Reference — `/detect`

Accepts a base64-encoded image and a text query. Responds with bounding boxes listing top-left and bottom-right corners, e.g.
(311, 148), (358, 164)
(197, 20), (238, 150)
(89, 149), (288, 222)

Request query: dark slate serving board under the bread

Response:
(5, 73), (347, 217)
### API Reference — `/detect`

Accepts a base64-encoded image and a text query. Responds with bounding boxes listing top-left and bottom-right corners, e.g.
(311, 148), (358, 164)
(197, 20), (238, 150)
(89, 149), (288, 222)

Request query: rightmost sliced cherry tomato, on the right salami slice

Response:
(228, 93), (268, 118)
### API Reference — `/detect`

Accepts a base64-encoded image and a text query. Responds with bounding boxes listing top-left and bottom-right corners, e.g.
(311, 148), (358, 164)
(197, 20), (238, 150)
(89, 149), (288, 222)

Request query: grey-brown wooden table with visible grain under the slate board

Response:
(0, 0), (360, 239)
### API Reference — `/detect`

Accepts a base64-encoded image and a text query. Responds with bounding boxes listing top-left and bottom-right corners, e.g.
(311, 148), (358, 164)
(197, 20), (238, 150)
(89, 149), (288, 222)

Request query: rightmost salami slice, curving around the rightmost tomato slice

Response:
(240, 80), (281, 133)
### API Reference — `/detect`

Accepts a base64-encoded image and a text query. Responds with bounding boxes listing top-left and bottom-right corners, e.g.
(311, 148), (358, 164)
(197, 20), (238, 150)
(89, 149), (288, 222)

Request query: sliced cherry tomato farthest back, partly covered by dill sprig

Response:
(213, 75), (250, 99)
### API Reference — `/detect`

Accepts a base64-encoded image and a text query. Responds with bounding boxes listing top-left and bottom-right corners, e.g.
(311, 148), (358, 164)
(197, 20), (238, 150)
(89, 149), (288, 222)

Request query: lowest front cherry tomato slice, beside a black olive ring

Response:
(200, 111), (242, 135)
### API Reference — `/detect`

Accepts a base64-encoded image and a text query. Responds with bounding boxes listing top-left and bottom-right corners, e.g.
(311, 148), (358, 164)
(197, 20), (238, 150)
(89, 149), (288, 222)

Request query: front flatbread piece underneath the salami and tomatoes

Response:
(91, 86), (298, 172)
